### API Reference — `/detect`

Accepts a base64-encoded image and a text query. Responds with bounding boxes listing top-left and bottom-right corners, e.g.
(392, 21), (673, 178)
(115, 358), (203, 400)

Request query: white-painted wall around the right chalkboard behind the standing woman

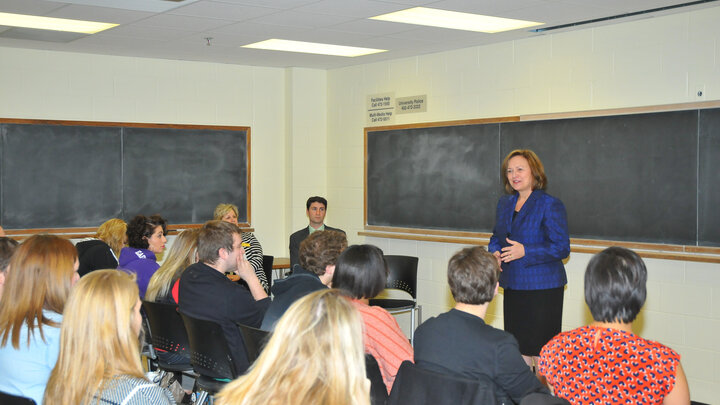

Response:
(328, 7), (720, 403)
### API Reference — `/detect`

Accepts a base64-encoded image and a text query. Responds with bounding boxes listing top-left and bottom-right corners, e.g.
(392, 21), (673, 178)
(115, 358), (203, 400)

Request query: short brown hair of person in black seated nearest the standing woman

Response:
(448, 246), (500, 305)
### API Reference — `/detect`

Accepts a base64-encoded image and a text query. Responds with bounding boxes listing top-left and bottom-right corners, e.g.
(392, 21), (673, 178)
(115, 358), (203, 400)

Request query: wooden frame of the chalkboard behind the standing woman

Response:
(360, 101), (720, 252)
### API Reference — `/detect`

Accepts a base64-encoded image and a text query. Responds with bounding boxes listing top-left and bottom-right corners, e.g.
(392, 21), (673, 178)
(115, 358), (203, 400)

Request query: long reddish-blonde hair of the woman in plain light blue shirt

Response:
(0, 234), (77, 349)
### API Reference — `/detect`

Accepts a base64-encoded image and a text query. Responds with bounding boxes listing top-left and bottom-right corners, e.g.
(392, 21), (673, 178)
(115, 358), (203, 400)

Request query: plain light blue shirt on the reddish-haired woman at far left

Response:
(0, 310), (62, 405)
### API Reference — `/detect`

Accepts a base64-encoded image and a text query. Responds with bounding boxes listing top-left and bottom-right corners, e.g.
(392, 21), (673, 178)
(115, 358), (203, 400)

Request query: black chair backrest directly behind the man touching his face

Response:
(180, 313), (238, 380)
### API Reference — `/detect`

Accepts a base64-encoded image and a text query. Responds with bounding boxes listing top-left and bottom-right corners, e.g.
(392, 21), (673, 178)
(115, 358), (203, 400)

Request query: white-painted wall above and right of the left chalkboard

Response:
(0, 48), (288, 256)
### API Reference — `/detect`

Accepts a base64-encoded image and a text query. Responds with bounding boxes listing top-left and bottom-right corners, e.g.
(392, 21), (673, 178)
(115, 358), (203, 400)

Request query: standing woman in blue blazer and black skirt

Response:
(488, 149), (570, 367)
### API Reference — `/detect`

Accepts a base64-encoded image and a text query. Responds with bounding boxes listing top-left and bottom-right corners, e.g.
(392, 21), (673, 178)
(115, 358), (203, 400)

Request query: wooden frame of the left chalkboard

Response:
(0, 118), (252, 230)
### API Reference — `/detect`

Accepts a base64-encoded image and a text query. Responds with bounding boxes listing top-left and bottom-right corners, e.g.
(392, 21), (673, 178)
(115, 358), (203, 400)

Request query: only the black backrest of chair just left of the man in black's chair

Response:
(142, 301), (190, 356)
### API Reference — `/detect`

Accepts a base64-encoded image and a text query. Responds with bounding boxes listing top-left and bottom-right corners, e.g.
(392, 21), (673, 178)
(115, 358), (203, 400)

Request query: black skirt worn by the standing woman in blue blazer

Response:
(503, 287), (565, 356)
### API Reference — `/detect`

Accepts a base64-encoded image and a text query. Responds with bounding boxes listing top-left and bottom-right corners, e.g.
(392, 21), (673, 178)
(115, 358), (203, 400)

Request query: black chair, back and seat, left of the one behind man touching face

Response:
(142, 301), (195, 381)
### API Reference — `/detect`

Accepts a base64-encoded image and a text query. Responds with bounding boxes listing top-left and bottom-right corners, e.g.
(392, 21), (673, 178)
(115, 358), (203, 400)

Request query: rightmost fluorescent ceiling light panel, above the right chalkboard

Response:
(370, 7), (544, 34)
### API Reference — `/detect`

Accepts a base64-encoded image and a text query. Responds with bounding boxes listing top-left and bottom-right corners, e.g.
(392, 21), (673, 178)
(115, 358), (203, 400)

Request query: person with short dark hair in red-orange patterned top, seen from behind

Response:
(539, 247), (690, 405)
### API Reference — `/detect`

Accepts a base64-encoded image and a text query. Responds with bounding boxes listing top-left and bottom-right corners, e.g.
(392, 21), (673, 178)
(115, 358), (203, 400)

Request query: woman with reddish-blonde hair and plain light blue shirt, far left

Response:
(0, 235), (80, 404)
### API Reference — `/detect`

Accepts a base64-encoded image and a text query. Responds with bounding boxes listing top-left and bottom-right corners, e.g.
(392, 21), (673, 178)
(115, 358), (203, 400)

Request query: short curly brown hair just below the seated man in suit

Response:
(299, 230), (347, 276)
